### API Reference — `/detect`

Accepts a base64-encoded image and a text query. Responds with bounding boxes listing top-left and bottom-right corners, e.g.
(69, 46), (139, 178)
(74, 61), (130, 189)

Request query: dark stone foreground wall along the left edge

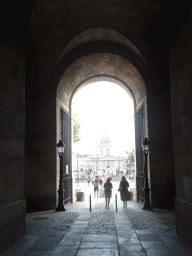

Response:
(0, 35), (26, 254)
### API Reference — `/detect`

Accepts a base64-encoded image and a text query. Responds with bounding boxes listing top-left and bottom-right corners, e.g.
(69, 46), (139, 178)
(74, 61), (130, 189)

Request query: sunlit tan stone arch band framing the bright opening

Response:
(56, 53), (148, 204)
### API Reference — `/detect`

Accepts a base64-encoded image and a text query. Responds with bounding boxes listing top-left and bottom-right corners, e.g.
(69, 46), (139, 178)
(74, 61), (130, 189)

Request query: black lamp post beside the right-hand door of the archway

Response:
(142, 138), (153, 210)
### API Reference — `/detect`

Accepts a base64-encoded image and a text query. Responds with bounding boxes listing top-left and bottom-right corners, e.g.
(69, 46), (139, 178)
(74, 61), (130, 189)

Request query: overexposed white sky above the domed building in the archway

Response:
(72, 81), (135, 155)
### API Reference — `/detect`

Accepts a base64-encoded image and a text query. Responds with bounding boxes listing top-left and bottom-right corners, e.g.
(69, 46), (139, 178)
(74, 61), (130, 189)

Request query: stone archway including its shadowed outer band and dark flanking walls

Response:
(25, 29), (174, 210)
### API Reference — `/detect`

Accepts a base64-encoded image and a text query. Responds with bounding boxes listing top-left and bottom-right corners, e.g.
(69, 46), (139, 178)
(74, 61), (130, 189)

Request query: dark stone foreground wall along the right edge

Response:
(170, 5), (192, 246)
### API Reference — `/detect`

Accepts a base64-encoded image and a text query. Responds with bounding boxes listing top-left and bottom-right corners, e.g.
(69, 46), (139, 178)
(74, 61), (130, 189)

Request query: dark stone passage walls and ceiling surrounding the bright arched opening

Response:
(0, 0), (192, 253)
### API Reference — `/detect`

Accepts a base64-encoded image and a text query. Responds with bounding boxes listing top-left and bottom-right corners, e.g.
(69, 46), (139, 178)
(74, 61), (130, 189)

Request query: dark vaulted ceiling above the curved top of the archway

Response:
(29, 0), (163, 52)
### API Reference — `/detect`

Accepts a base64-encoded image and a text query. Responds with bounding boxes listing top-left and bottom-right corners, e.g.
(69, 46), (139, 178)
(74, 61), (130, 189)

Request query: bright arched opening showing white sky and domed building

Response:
(71, 79), (135, 200)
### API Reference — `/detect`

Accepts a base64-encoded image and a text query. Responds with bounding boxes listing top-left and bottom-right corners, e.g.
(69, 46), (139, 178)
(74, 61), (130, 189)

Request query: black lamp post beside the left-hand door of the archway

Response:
(56, 140), (65, 211)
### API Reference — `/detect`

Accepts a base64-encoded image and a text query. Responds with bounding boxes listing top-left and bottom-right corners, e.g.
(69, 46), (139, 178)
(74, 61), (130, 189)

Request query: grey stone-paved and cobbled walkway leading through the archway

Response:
(3, 197), (192, 256)
